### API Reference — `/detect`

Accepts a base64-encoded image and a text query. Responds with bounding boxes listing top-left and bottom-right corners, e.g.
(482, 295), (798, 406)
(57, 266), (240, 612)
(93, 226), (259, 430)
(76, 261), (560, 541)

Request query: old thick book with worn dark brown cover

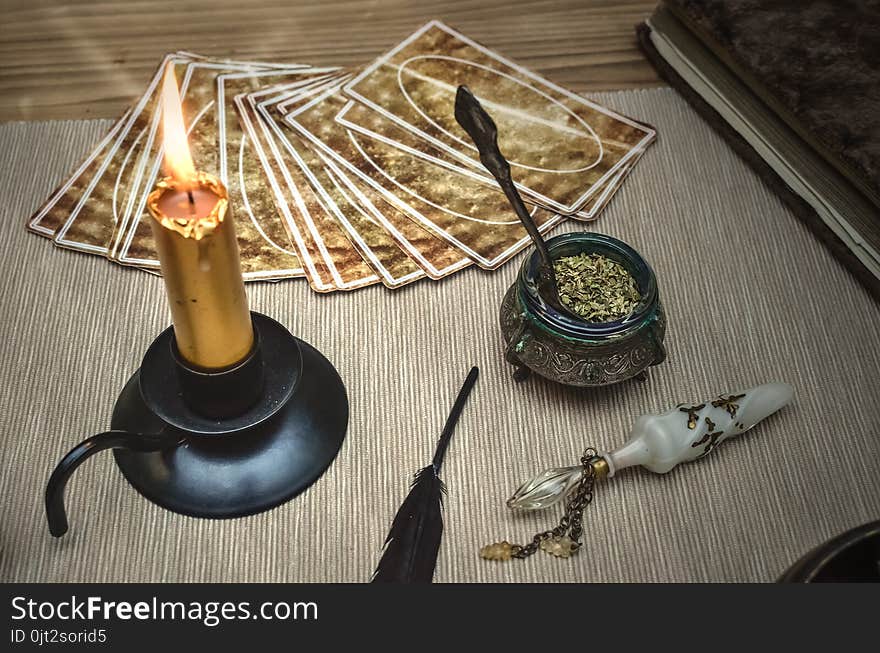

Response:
(638, 0), (880, 298)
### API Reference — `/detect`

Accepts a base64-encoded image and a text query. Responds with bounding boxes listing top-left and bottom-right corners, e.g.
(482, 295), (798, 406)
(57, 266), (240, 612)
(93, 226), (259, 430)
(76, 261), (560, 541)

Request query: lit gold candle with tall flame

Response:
(147, 65), (254, 370)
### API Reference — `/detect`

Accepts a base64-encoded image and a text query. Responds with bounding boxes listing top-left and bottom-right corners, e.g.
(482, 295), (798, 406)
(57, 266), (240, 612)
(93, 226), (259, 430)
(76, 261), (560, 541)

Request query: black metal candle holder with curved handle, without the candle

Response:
(46, 313), (348, 537)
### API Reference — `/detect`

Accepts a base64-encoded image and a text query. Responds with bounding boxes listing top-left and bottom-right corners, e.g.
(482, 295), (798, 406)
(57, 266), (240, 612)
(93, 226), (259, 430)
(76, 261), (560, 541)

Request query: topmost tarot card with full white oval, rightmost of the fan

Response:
(345, 21), (655, 214)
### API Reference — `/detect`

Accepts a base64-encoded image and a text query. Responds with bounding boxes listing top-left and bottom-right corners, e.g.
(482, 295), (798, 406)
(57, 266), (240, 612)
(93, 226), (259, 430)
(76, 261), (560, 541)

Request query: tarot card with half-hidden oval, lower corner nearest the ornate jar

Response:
(285, 81), (562, 269)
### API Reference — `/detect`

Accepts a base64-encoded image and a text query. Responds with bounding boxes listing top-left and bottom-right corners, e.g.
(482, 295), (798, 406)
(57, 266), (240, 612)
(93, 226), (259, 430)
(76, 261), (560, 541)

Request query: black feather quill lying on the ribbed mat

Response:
(372, 367), (479, 583)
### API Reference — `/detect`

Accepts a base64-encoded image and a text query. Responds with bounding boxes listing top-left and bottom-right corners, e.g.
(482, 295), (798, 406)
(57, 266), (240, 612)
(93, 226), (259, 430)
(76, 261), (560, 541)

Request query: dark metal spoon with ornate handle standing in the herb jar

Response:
(455, 85), (582, 320)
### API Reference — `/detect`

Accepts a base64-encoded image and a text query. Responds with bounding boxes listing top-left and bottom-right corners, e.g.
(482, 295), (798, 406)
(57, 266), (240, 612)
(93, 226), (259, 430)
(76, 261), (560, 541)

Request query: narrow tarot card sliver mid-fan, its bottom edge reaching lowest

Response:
(234, 79), (379, 292)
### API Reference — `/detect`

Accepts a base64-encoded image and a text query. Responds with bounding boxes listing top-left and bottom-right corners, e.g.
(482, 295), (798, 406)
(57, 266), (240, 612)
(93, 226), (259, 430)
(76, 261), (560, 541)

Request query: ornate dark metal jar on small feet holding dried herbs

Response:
(500, 232), (666, 387)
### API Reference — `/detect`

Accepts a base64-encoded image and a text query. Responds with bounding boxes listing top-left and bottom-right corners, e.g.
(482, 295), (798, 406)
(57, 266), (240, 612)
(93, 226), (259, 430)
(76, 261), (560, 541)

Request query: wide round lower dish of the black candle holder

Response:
(111, 336), (348, 517)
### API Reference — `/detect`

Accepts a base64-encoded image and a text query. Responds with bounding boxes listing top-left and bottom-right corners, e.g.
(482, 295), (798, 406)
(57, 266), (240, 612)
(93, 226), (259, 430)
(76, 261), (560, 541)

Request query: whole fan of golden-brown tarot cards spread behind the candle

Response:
(27, 21), (655, 292)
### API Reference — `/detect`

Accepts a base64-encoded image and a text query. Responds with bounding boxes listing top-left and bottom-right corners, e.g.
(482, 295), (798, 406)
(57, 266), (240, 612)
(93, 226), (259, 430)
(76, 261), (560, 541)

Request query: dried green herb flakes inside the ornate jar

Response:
(553, 254), (641, 322)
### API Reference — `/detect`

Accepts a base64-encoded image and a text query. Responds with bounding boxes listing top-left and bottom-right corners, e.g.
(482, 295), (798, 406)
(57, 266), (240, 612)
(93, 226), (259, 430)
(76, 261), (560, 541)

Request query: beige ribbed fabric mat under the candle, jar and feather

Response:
(0, 89), (880, 582)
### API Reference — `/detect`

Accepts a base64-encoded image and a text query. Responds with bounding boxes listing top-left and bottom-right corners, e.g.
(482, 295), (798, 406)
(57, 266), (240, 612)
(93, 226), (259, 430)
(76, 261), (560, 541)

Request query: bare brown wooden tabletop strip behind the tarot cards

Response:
(0, 0), (660, 121)
